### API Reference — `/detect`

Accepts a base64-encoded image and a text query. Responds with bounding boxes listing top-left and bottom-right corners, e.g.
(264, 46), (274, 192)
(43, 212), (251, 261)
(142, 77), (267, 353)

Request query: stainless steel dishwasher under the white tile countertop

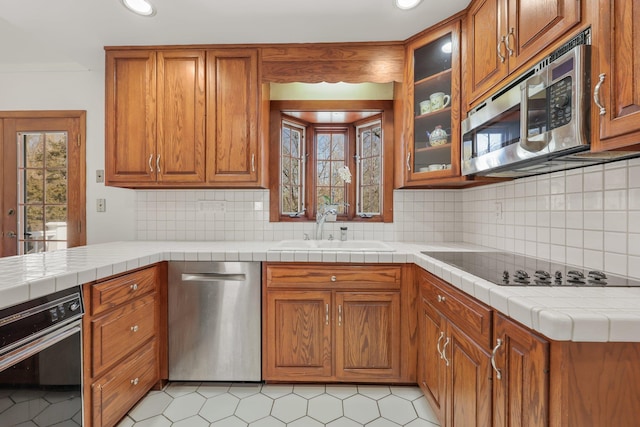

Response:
(169, 261), (261, 381)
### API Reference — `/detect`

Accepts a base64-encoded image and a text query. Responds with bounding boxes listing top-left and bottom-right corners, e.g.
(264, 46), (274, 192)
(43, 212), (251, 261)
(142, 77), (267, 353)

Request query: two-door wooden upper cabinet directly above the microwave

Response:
(463, 0), (580, 105)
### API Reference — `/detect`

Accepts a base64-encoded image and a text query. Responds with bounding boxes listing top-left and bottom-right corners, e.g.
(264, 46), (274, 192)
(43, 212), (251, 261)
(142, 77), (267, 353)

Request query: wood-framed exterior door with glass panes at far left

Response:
(0, 112), (86, 256)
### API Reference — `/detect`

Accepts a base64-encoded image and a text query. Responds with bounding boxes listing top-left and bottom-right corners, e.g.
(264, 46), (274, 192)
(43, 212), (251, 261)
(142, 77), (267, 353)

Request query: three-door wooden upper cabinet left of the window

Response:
(105, 48), (261, 187)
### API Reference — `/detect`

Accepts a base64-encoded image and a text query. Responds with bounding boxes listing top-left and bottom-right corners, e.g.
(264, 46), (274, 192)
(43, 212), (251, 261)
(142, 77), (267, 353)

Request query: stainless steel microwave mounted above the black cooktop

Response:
(461, 43), (602, 177)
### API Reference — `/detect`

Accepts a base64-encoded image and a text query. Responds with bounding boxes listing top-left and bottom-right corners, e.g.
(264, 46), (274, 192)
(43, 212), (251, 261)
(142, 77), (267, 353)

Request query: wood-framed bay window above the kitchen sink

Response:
(270, 101), (393, 222)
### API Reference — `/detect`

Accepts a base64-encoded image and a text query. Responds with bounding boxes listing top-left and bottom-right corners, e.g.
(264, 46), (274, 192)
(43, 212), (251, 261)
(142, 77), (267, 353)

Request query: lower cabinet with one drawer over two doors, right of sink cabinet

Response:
(418, 271), (491, 427)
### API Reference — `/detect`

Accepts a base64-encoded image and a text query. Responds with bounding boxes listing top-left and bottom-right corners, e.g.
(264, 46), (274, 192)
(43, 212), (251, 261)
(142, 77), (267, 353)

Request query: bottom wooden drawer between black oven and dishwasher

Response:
(91, 340), (159, 427)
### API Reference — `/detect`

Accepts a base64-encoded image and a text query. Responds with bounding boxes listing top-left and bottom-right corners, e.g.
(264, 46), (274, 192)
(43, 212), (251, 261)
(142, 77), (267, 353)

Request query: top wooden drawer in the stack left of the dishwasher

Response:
(91, 267), (157, 314)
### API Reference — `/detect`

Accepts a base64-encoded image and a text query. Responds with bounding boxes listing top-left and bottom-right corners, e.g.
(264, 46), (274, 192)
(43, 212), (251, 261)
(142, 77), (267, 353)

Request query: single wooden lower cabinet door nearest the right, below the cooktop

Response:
(493, 314), (549, 427)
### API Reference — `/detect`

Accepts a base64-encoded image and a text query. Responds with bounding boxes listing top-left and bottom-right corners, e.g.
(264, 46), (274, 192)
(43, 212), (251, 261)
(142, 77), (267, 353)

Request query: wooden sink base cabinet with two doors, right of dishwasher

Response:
(263, 263), (415, 383)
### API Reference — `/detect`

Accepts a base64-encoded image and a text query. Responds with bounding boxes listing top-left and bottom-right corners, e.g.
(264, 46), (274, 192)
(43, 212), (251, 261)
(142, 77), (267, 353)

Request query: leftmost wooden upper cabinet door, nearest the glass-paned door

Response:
(105, 50), (156, 185)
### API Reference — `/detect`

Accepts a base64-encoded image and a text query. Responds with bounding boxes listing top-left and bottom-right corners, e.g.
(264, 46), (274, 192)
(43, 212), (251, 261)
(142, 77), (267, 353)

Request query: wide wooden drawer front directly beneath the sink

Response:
(266, 263), (402, 289)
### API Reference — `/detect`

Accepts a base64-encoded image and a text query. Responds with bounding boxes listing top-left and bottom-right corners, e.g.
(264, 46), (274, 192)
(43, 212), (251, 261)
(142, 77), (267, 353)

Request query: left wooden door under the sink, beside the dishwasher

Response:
(264, 291), (332, 381)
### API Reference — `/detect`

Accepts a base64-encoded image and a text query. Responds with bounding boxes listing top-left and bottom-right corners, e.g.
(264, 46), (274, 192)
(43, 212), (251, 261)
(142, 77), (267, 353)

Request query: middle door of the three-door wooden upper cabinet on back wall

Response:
(152, 50), (205, 183)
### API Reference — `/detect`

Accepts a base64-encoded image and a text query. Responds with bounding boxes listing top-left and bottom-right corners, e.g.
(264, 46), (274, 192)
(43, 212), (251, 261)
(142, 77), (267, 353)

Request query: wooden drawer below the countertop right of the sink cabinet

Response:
(419, 271), (492, 349)
